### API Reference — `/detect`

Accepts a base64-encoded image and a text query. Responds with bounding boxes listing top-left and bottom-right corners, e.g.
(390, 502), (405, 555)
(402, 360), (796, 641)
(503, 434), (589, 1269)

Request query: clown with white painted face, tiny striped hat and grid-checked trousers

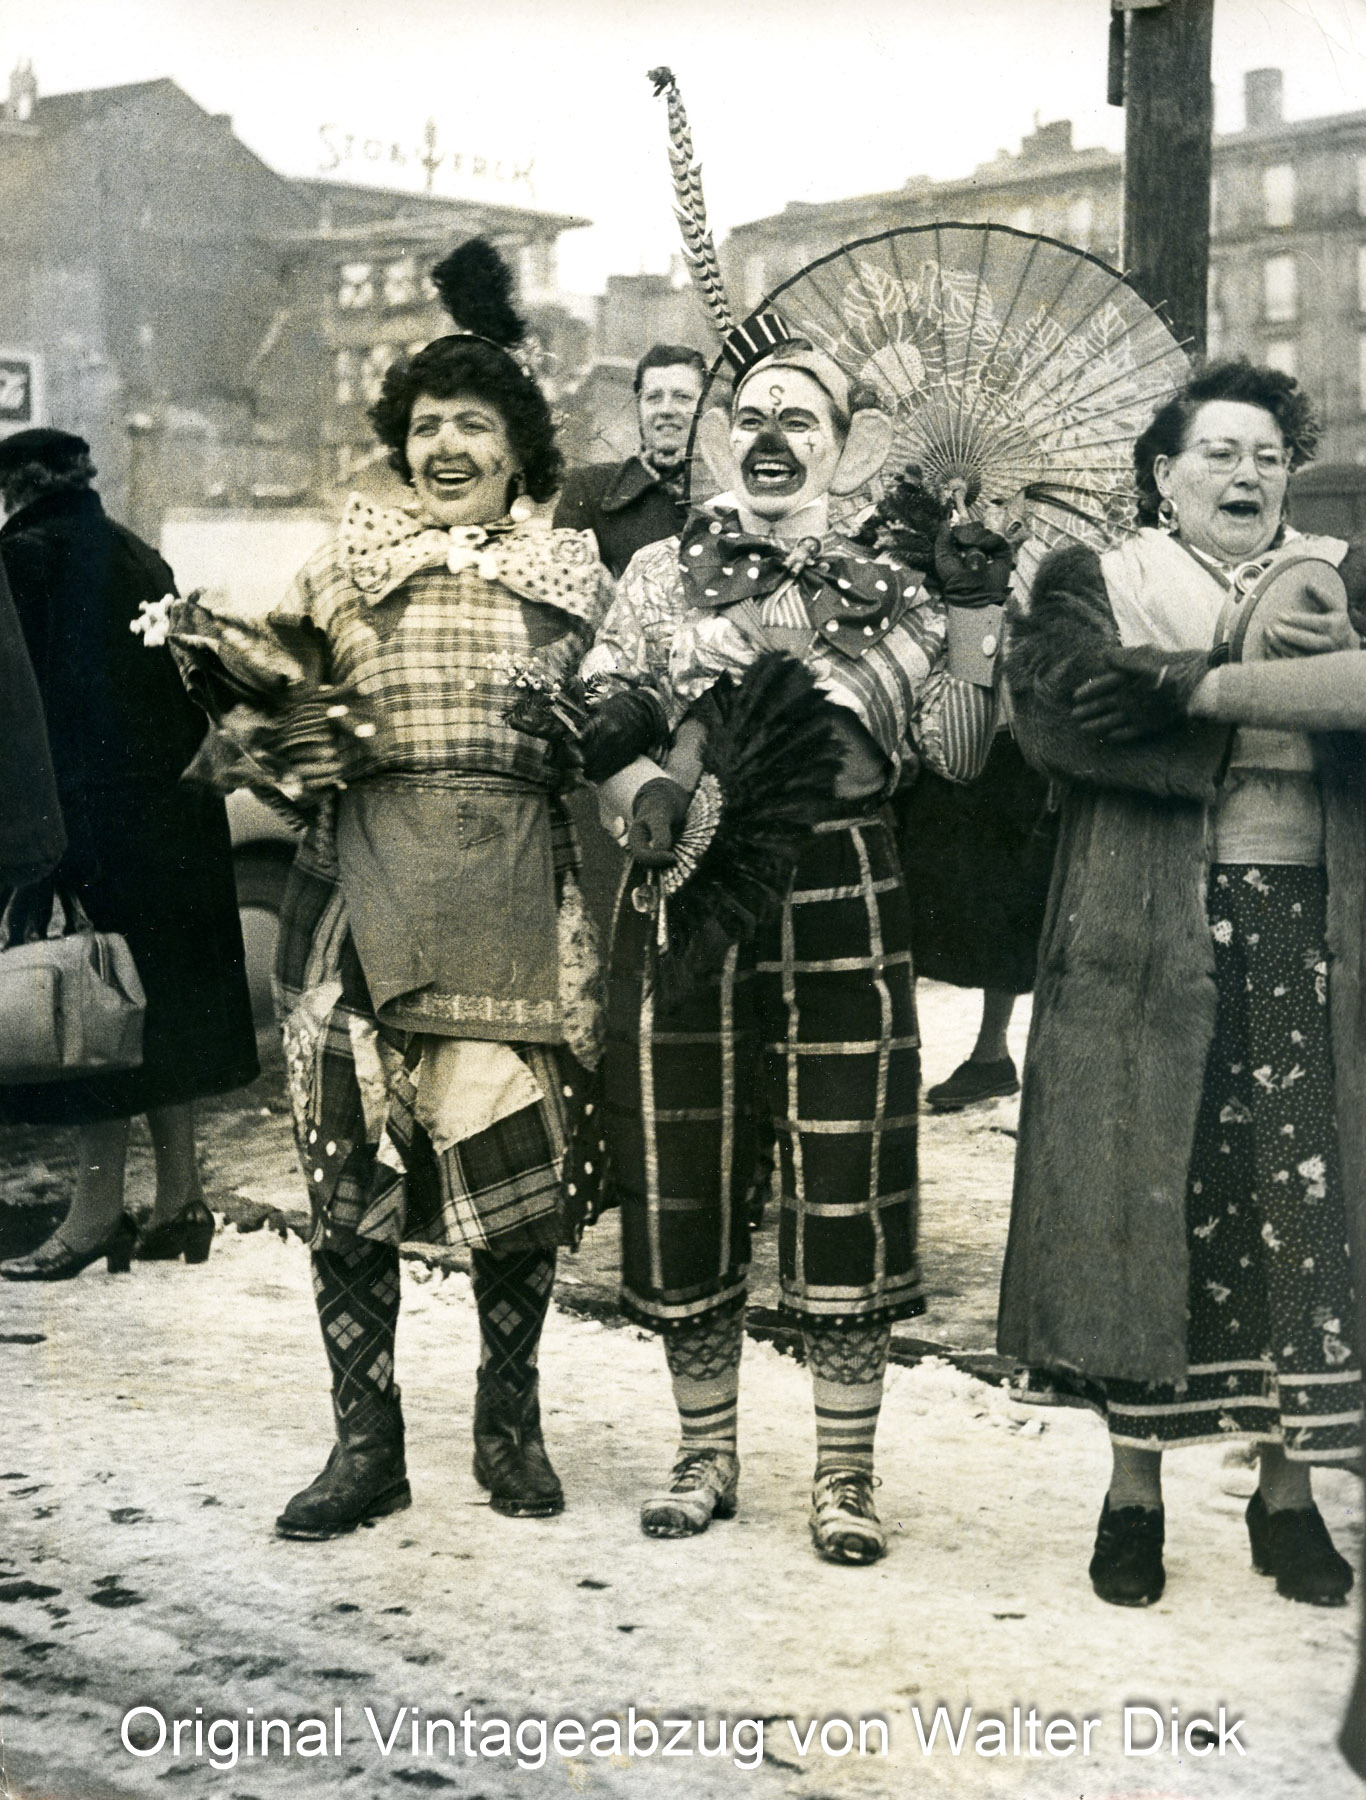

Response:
(583, 313), (1010, 1562)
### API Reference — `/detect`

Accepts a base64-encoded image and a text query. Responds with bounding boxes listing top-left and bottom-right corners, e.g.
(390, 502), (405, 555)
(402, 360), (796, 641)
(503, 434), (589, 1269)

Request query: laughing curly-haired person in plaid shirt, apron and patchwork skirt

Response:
(157, 239), (610, 1537)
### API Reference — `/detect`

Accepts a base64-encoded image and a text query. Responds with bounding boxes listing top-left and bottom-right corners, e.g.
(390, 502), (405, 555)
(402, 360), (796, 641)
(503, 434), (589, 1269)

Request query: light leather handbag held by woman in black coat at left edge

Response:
(0, 889), (148, 1085)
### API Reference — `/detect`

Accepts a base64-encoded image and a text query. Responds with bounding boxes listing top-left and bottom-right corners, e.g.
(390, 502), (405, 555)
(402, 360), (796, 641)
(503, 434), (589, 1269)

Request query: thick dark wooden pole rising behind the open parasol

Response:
(1109, 0), (1215, 356)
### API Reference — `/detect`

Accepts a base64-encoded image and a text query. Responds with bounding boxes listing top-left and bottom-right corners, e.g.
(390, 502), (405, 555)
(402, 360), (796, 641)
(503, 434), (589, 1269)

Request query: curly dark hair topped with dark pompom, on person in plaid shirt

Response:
(369, 238), (563, 500)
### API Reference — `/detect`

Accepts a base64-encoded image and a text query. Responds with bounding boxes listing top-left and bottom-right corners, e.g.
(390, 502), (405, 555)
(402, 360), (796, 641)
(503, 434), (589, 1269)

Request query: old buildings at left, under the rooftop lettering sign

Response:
(0, 65), (589, 536)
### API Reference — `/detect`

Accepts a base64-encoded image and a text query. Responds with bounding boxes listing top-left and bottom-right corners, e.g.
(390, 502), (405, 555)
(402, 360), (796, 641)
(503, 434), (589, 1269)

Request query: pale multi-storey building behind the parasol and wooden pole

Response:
(720, 68), (1366, 464)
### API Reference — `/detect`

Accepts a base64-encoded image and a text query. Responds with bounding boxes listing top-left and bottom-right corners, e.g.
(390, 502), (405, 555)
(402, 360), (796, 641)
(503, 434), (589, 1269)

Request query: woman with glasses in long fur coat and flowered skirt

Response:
(1001, 351), (1366, 1606)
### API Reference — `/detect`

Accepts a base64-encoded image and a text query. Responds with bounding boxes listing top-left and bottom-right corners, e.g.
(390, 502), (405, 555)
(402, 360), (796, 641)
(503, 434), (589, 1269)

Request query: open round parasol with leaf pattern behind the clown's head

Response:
(696, 225), (1188, 576)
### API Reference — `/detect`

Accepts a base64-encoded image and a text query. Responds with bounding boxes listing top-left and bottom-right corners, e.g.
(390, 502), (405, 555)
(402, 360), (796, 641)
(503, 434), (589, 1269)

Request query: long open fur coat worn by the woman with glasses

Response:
(999, 549), (1366, 1381)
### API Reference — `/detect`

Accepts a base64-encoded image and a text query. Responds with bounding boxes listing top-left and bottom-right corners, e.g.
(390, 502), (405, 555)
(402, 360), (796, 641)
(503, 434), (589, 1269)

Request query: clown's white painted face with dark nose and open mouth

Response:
(731, 367), (846, 518)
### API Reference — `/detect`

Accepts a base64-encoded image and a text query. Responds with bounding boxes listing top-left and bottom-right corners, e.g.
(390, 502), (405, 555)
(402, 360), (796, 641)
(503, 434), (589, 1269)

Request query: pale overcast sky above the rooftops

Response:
(0, 0), (1366, 292)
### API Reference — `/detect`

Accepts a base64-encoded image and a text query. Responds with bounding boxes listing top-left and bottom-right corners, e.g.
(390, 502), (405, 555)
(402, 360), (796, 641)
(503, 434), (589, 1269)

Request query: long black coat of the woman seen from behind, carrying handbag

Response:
(0, 490), (257, 1123)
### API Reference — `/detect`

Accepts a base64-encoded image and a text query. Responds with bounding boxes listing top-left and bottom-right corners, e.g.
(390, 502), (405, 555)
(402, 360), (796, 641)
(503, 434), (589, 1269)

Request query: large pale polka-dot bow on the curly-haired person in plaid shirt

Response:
(337, 493), (603, 619)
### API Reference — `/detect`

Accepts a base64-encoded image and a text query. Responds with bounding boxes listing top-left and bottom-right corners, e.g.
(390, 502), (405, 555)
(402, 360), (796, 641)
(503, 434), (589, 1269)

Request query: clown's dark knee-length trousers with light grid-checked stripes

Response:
(603, 815), (923, 1330)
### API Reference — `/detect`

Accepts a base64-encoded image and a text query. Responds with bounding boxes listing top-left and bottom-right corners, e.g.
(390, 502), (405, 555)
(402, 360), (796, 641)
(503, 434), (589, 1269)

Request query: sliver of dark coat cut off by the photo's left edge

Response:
(0, 562), (67, 889)
